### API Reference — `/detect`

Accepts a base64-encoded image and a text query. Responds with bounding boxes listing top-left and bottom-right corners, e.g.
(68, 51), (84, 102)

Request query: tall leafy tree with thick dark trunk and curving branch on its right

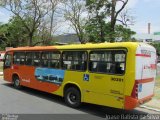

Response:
(86, 0), (129, 42)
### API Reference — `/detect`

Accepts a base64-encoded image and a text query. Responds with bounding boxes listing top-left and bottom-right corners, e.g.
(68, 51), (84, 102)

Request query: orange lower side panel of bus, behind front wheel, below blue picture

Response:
(12, 65), (60, 93)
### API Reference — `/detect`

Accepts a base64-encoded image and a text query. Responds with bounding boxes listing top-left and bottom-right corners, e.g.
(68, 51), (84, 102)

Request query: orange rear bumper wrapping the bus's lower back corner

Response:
(124, 94), (154, 110)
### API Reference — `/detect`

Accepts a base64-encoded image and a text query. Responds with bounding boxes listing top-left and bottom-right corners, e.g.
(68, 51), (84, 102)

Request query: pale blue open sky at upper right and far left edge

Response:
(0, 0), (160, 33)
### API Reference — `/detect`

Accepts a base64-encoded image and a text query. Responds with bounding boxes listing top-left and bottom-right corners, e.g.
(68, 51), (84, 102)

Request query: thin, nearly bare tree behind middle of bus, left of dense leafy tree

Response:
(63, 0), (87, 43)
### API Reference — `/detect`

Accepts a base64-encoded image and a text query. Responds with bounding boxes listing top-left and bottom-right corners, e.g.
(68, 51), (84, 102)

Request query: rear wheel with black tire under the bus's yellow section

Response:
(64, 87), (81, 108)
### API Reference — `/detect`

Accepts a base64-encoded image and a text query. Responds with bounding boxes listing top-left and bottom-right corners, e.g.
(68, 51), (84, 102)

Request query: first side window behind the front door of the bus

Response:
(13, 52), (25, 65)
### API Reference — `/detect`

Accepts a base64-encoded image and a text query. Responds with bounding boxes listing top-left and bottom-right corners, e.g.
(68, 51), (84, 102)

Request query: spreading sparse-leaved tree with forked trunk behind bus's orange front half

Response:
(0, 0), (50, 46)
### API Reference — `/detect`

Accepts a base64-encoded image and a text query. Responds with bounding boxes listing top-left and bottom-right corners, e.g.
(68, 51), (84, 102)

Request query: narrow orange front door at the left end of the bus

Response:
(3, 52), (12, 81)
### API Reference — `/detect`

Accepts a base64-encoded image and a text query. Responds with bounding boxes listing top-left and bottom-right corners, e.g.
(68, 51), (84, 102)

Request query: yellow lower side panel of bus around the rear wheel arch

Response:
(53, 71), (124, 108)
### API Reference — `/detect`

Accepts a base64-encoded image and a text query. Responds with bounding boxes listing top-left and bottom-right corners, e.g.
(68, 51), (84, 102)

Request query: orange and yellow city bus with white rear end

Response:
(4, 42), (157, 110)
